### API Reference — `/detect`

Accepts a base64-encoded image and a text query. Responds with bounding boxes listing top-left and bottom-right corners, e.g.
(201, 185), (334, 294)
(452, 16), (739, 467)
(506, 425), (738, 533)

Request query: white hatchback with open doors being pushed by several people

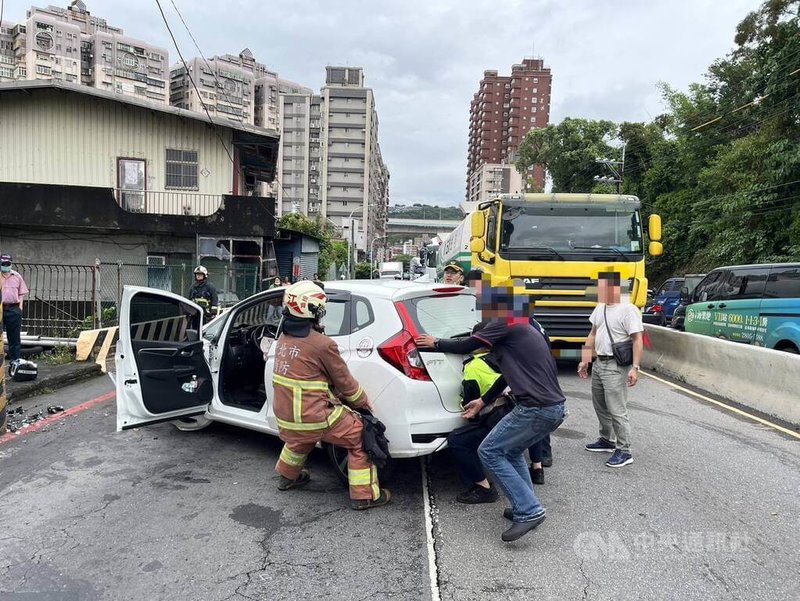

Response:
(115, 280), (480, 479)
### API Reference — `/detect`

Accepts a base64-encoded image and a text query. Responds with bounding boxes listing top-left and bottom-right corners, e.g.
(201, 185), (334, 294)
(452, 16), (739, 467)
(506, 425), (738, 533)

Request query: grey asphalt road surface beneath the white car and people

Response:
(0, 371), (800, 600)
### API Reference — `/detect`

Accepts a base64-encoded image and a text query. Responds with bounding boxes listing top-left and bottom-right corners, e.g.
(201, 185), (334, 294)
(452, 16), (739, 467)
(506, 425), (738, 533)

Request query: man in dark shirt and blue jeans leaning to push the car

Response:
(416, 282), (566, 542)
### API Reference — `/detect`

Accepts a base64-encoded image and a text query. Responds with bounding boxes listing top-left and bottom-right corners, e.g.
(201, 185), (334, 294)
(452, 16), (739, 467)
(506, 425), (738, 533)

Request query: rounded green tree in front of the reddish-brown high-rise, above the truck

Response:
(516, 117), (619, 192)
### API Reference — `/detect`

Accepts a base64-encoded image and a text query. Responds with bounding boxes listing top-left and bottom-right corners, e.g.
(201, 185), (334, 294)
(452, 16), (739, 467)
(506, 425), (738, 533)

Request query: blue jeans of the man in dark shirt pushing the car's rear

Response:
(478, 403), (564, 522)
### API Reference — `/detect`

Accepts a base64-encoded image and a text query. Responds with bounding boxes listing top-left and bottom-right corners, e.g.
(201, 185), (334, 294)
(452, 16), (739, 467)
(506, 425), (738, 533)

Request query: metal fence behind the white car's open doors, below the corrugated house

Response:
(15, 261), (261, 338)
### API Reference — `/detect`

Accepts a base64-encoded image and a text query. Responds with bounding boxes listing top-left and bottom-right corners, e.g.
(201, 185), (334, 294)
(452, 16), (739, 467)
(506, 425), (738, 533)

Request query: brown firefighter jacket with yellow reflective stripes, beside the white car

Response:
(272, 329), (367, 432)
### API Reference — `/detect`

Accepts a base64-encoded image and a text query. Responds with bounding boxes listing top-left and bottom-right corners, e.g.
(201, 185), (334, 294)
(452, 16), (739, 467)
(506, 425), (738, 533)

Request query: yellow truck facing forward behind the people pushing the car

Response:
(462, 194), (663, 358)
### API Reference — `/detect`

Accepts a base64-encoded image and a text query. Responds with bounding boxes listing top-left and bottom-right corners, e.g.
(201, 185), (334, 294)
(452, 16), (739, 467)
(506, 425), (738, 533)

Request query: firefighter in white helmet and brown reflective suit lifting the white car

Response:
(272, 280), (392, 510)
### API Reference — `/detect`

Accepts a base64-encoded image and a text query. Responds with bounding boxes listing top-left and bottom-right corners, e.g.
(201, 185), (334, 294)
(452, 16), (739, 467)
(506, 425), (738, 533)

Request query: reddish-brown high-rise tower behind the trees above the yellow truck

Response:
(467, 58), (552, 201)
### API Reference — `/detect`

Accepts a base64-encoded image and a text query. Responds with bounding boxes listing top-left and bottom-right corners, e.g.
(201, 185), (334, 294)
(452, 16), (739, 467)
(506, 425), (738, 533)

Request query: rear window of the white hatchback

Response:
(403, 294), (480, 338)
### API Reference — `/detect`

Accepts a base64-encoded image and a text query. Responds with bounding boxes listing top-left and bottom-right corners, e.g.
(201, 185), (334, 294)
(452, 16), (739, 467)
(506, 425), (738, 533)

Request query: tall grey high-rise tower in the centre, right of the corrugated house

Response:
(277, 67), (389, 255)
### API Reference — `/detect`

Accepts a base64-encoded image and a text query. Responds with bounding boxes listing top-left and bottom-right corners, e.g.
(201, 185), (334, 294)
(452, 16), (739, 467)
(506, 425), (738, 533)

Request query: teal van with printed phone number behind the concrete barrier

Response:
(686, 263), (800, 353)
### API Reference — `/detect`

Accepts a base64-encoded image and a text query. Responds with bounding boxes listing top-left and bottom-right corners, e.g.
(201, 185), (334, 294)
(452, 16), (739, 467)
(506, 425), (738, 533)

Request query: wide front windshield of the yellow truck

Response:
(500, 204), (643, 261)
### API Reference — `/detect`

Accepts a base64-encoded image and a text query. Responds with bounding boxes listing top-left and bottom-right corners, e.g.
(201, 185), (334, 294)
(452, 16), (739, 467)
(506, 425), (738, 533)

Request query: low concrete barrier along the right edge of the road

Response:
(642, 325), (800, 425)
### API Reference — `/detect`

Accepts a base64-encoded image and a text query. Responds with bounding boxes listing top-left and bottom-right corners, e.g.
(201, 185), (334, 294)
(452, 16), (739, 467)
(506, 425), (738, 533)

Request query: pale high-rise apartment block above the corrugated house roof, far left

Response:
(0, 0), (169, 104)
